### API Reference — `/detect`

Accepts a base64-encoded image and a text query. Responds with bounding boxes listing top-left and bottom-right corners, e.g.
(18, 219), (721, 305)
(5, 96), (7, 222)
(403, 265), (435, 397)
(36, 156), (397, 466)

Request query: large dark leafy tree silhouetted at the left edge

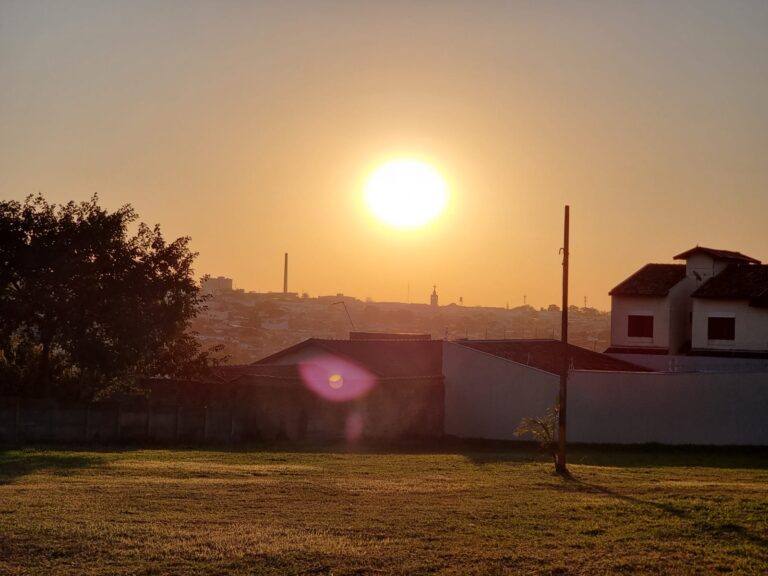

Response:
(0, 195), (216, 399)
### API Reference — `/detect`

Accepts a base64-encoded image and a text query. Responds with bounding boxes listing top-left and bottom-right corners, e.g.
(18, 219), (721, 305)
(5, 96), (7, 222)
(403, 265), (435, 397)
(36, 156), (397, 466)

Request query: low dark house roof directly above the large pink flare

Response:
(253, 338), (443, 378)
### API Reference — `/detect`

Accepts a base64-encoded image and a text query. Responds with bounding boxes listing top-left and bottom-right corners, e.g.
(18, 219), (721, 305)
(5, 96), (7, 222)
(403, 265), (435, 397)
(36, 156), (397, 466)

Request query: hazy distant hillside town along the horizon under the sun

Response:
(193, 277), (611, 364)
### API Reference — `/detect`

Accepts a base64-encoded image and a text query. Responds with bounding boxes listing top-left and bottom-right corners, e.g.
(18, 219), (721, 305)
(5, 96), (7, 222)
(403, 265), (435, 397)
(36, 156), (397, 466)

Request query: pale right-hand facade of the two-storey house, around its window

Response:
(691, 298), (768, 352)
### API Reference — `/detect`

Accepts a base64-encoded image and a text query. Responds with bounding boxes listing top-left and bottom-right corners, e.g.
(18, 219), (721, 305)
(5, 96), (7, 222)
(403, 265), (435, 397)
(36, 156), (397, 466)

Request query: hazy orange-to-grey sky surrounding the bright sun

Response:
(0, 0), (768, 309)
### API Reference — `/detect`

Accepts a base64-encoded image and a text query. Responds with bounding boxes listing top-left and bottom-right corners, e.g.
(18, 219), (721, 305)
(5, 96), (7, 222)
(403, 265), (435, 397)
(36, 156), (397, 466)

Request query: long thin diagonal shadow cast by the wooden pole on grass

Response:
(561, 473), (768, 548)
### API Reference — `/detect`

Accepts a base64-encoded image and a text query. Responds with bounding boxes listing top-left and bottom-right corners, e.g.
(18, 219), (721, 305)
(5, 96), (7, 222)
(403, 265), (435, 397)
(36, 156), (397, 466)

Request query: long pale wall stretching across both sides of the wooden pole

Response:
(443, 342), (768, 446)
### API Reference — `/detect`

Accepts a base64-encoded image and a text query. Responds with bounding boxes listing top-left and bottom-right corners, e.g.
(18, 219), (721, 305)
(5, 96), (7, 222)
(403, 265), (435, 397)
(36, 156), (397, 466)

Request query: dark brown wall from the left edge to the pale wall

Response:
(0, 377), (445, 444)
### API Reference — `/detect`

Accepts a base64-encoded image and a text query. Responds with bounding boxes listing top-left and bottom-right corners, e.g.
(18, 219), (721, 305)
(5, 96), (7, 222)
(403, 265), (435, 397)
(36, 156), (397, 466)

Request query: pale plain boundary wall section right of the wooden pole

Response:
(568, 371), (768, 446)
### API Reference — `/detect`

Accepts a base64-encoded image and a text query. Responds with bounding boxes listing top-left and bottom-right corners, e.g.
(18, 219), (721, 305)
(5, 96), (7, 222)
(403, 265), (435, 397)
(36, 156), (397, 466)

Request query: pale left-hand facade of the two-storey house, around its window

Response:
(611, 296), (670, 349)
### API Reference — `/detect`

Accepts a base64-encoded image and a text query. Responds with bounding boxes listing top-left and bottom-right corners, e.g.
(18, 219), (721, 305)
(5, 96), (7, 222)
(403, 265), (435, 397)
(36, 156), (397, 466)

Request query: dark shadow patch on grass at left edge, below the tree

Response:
(0, 448), (106, 485)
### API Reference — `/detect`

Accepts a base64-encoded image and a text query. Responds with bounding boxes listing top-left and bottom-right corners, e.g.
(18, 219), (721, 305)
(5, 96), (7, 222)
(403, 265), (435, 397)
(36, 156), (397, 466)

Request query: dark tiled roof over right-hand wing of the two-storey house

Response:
(691, 264), (768, 308)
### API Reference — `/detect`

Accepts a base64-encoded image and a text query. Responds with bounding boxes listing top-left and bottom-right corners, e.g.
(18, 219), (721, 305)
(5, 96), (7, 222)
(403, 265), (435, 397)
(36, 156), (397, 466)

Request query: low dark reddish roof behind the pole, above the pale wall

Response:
(457, 339), (651, 375)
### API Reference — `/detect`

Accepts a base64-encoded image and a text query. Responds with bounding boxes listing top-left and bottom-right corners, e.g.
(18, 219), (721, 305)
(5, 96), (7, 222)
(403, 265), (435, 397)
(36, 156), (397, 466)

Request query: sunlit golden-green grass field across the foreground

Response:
(0, 448), (768, 575)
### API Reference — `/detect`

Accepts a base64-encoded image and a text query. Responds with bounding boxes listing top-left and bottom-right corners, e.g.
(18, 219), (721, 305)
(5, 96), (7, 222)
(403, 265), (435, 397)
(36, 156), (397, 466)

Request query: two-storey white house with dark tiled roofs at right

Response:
(607, 246), (768, 356)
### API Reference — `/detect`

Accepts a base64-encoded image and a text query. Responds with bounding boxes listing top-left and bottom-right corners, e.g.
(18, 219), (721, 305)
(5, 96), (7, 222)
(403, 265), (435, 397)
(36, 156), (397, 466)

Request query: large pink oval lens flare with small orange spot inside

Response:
(299, 354), (376, 402)
